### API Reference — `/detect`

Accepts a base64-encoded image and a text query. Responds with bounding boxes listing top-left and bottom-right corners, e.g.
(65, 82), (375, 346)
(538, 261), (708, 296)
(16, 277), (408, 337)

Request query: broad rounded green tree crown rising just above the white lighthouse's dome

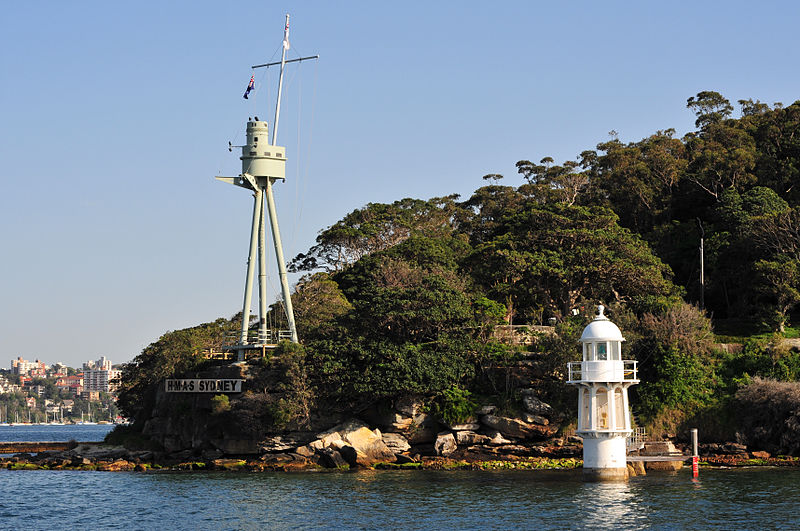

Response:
(465, 203), (676, 317)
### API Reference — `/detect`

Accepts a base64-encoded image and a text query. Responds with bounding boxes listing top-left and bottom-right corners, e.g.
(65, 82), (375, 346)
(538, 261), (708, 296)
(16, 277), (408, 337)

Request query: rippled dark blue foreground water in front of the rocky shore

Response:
(0, 427), (800, 530)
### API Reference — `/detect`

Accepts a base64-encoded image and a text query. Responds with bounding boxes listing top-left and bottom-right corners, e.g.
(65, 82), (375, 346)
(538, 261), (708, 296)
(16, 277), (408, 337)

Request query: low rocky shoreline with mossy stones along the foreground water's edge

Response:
(0, 436), (800, 476)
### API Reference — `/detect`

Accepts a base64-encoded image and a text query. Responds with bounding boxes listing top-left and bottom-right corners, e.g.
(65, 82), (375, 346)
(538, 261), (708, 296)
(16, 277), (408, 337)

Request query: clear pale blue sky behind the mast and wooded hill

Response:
(0, 0), (800, 367)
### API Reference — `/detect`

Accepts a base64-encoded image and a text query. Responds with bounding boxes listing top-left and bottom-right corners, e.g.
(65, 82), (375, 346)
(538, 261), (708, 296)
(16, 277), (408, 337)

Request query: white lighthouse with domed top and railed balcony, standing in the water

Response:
(567, 306), (639, 480)
